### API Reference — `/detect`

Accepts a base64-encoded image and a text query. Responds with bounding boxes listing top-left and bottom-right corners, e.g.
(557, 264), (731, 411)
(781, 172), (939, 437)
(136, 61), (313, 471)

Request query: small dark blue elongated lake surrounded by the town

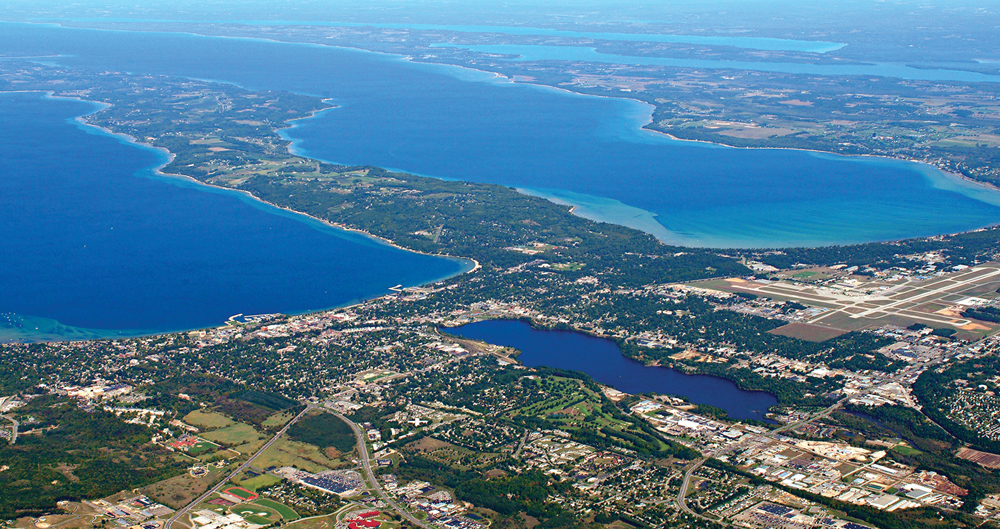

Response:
(443, 320), (778, 420)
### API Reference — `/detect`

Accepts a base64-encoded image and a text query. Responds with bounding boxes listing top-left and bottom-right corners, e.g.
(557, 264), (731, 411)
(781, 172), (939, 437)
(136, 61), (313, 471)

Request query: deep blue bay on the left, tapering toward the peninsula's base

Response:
(0, 93), (469, 341)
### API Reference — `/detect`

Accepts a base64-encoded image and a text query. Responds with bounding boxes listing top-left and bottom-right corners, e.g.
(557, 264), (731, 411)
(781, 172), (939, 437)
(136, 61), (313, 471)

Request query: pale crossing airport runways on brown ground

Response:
(732, 263), (1000, 325)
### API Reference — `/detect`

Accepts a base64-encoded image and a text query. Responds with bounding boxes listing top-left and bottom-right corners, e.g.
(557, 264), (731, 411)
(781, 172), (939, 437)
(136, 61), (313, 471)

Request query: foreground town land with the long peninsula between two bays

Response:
(0, 56), (1000, 529)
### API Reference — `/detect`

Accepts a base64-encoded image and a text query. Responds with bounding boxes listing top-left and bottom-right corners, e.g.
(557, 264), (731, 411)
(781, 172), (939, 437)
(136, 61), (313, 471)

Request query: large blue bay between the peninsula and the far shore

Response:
(0, 24), (1000, 247)
